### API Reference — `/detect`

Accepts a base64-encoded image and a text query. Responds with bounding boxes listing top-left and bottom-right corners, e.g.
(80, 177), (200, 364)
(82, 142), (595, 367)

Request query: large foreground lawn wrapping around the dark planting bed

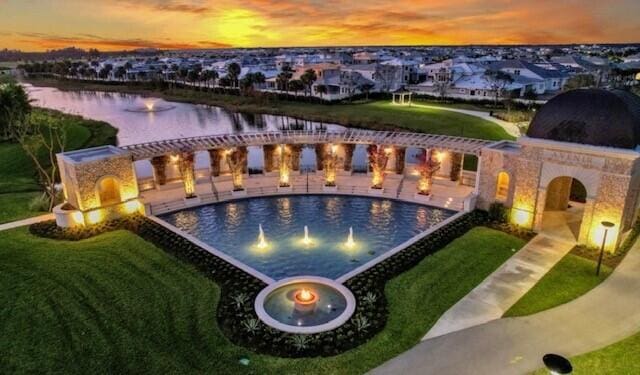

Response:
(0, 228), (523, 374)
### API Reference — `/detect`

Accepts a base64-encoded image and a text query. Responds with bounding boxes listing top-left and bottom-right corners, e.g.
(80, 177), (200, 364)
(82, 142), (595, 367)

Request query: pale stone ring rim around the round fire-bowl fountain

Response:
(254, 276), (356, 334)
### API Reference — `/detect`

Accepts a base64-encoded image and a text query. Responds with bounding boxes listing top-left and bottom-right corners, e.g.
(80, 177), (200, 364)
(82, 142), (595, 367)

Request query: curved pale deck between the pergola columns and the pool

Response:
(140, 173), (474, 215)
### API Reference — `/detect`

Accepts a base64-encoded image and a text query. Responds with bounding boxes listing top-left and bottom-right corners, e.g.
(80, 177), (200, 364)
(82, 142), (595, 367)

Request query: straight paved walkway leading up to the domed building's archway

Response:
(423, 235), (575, 340)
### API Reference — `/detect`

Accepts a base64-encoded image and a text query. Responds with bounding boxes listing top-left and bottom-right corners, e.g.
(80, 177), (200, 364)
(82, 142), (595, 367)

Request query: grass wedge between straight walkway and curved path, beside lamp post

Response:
(504, 253), (612, 317)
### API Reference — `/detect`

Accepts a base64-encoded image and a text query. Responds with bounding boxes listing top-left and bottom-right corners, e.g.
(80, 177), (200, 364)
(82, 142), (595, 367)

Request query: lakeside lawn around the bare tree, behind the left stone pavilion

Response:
(0, 108), (117, 223)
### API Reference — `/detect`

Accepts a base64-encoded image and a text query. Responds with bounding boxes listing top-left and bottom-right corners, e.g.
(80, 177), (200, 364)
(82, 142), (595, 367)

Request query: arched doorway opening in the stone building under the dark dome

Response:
(539, 176), (587, 241)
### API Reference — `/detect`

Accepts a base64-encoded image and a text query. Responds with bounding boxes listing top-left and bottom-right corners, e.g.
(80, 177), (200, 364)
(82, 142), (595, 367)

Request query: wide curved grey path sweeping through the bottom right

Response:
(372, 242), (640, 375)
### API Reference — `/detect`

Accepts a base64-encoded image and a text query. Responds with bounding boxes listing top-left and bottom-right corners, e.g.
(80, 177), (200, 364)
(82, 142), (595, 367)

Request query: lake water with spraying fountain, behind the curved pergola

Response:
(26, 85), (343, 145)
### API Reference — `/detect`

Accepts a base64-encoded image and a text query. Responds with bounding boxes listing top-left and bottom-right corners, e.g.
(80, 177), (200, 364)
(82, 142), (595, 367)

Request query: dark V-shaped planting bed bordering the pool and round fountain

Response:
(30, 211), (486, 357)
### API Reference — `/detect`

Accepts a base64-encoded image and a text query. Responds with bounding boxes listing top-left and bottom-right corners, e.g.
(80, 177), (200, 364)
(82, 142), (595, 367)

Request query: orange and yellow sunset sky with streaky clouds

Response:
(0, 0), (640, 51)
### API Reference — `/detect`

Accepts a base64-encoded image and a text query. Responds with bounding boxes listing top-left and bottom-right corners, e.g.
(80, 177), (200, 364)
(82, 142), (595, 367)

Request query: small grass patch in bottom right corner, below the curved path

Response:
(535, 333), (640, 375)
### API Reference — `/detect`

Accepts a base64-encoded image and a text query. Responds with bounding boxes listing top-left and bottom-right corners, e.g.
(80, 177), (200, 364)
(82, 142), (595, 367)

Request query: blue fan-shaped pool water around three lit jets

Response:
(161, 195), (454, 280)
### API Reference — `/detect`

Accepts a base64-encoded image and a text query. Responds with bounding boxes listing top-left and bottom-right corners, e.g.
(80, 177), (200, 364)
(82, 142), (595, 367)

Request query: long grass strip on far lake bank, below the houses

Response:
(30, 78), (513, 140)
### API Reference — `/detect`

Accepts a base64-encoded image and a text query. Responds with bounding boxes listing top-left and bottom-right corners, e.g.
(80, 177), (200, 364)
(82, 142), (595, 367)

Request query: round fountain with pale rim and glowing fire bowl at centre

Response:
(255, 276), (356, 333)
